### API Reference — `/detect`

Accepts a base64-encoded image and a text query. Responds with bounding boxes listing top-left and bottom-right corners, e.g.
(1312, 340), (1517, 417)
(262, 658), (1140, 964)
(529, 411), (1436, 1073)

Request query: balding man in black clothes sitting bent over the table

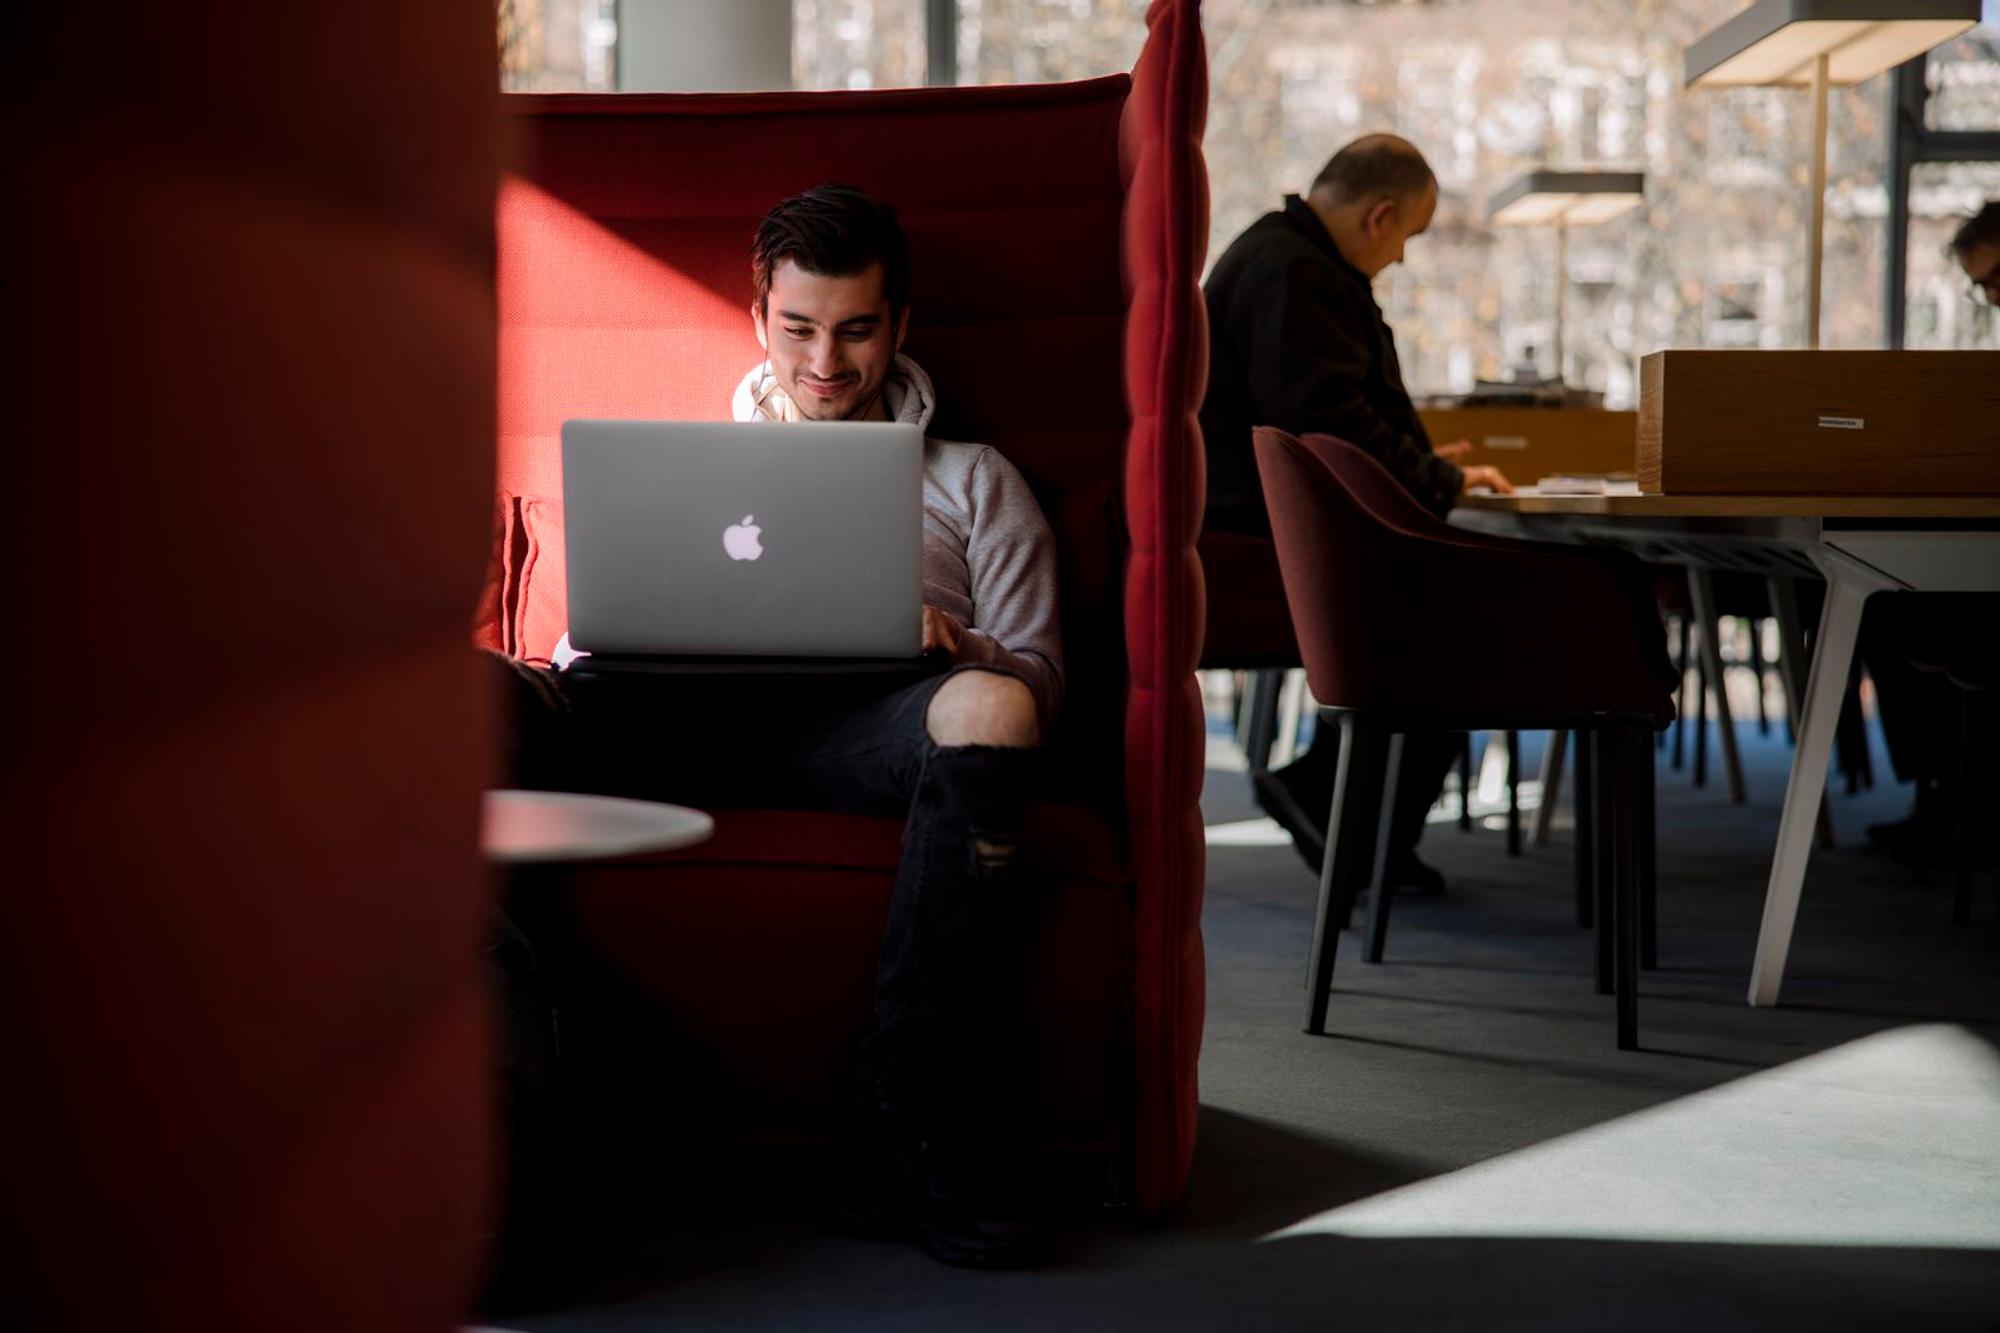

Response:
(1202, 134), (1512, 889)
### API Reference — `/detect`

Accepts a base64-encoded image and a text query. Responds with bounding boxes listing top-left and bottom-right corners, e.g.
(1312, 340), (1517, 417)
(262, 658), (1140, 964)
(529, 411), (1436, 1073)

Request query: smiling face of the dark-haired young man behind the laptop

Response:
(750, 260), (908, 420)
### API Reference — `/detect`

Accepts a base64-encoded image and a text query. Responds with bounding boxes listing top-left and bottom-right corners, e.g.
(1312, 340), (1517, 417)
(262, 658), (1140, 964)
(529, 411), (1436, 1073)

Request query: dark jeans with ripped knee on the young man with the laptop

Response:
(508, 662), (1040, 1141)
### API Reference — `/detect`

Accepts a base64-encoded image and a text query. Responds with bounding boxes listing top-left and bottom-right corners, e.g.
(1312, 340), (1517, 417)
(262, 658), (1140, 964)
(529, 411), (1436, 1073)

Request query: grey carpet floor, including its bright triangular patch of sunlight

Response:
(494, 725), (2000, 1333)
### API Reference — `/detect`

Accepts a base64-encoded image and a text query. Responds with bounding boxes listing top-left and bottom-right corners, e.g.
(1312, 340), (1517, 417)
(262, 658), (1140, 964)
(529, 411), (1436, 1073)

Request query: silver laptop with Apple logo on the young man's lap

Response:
(562, 420), (924, 658)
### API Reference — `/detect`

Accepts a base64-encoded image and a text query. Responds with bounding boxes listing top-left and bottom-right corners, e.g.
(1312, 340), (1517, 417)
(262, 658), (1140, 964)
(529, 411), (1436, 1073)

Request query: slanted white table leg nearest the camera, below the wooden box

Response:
(1750, 550), (1884, 1005)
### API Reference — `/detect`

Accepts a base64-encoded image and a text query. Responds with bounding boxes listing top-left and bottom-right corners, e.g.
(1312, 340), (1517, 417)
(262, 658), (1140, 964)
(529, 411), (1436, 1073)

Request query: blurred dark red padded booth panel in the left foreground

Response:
(0, 0), (496, 1333)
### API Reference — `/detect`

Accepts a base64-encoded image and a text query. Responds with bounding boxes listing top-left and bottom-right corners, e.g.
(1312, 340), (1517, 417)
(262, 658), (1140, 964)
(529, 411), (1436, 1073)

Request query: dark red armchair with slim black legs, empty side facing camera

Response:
(1254, 426), (1674, 1049)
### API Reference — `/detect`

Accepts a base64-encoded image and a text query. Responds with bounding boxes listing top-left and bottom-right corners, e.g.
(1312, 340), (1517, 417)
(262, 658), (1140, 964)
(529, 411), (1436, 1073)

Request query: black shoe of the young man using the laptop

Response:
(824, 1151), (1048, 1269)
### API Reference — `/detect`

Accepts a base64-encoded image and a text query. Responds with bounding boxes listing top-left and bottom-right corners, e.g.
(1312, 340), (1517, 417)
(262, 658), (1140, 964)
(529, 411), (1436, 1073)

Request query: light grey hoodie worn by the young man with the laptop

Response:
(730, 354), (1062, 731)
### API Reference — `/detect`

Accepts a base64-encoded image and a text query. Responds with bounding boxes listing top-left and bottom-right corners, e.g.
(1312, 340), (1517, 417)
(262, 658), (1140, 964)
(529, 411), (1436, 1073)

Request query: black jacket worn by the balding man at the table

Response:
(1202, 194), (1464, 534)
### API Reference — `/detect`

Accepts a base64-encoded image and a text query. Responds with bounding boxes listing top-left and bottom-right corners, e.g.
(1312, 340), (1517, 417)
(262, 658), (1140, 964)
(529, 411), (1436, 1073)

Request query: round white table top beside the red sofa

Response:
(480, 791), (716, 865)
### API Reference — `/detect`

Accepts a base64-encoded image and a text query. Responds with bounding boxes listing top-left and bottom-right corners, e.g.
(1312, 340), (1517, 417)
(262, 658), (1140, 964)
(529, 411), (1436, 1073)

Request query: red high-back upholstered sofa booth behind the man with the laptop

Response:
(480, 0), (1208, 1205)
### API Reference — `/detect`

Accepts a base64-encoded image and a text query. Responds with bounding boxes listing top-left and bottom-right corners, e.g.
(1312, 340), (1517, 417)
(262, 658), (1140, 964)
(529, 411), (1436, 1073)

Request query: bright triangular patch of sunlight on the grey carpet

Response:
(1266, 1025), (2000, 1249)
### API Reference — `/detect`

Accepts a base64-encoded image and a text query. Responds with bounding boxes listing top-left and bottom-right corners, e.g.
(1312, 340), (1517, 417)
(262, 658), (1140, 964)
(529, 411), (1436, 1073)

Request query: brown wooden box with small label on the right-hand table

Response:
(1638, 350), (2000, 496)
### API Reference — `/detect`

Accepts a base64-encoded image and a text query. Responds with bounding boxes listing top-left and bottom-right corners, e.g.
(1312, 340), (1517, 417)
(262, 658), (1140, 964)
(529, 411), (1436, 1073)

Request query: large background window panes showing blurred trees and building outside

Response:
(502, 0), (2000, 374)
